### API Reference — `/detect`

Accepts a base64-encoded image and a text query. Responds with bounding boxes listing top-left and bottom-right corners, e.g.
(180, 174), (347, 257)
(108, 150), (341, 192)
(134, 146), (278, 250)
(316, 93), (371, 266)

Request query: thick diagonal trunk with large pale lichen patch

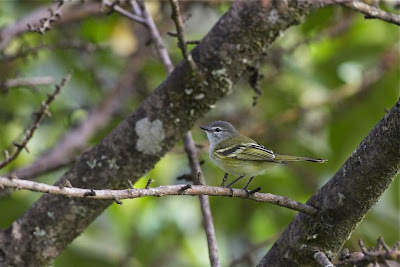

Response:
(0, 0), (310, 266)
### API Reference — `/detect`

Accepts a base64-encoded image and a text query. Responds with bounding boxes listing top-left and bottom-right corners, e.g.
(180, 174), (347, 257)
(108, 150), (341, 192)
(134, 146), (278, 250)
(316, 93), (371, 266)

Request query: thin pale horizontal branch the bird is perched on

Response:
(0, 177), (317, 215)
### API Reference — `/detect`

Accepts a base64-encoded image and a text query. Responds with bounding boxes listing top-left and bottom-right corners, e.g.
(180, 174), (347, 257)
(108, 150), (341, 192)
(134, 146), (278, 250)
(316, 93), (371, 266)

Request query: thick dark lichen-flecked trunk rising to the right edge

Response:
(258, 100), (400, 266)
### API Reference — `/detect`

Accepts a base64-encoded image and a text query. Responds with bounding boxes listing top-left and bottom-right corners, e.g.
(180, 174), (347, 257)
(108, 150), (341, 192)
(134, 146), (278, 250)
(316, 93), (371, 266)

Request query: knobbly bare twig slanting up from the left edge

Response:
(0, 73), (71, 169)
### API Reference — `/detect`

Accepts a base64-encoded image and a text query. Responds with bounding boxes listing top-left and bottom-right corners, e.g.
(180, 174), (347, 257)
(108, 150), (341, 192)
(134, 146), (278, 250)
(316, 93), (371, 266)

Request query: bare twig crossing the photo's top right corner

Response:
(334, 0), (400, 26)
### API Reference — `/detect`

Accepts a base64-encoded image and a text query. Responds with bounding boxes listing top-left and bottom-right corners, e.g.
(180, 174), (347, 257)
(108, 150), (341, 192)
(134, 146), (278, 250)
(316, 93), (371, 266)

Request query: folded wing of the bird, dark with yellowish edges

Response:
(214, 143), (275, 162)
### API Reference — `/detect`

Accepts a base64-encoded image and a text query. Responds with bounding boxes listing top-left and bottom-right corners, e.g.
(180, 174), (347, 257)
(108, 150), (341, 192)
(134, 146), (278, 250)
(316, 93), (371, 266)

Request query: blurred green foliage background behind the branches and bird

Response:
(0, 1), (400, 267)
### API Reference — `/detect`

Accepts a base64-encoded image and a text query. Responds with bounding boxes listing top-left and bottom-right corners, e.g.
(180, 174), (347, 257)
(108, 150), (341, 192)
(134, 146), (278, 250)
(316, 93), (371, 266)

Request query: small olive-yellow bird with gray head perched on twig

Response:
(200, 121), (327, 195)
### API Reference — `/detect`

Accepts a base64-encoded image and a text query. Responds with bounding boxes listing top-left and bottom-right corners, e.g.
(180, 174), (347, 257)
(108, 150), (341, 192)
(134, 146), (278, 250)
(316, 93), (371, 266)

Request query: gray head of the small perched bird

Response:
(200, 121), (239, 147)
